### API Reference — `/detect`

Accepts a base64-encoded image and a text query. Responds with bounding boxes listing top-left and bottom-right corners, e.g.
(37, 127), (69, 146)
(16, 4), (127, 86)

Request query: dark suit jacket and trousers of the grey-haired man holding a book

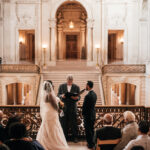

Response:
(58, 83), (80, 138)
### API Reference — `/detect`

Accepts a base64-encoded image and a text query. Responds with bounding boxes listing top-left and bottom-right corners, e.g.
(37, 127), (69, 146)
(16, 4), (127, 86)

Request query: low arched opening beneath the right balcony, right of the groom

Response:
(111, 83), (136, 105)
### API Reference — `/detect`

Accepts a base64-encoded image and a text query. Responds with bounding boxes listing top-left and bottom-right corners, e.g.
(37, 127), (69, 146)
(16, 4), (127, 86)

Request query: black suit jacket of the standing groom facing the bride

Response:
(82, 90), (97, 120)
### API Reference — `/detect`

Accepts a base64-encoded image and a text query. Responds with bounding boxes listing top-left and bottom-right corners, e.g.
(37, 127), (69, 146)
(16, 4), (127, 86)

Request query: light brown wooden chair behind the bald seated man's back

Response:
(96, 138), (121, 150)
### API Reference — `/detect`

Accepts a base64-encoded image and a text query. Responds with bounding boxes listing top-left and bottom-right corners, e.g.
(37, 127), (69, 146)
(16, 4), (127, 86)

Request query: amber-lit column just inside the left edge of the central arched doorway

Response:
(57, 25), (63, 59)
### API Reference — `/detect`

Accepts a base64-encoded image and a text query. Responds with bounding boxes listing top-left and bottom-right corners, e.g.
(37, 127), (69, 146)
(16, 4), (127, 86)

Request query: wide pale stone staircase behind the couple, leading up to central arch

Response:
(43, 61), (102, 105)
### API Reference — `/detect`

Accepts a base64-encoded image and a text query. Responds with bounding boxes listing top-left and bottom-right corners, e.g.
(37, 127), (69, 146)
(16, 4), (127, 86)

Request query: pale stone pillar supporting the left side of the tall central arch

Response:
(49, 19), (57, 65)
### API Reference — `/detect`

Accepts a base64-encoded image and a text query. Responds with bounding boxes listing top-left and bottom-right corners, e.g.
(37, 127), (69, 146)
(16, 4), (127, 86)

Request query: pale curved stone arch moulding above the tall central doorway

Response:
(50, 0), (93, 19)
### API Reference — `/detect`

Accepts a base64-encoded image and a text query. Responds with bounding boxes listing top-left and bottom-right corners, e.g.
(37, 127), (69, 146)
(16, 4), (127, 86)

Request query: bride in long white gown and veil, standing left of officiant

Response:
(37, 81), (69, 150)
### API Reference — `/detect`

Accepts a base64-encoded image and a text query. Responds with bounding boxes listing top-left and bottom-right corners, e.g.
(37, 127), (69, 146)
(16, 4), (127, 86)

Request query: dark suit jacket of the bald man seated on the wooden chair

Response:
(95, 126), (121, 150)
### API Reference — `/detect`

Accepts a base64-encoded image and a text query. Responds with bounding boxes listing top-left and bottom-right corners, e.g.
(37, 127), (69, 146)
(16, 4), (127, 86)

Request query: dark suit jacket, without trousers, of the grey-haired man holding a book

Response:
(58, 83), (80, 109)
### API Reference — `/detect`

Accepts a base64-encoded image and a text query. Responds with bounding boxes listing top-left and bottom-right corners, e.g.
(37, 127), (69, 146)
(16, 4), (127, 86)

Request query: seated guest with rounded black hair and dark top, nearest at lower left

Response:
(5, 123), (36, 150)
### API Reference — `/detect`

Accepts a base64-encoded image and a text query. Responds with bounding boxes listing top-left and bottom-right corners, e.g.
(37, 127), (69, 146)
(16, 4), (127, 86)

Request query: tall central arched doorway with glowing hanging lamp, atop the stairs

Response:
(56, 2), (87, 60)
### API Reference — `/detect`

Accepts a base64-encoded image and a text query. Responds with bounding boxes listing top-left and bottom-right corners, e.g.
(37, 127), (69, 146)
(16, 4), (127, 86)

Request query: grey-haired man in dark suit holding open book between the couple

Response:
(58, 75), (80, 143)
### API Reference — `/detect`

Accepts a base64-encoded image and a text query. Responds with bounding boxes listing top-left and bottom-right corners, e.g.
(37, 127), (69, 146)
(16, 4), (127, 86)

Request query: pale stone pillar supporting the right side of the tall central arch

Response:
(87, 19), (93, 65)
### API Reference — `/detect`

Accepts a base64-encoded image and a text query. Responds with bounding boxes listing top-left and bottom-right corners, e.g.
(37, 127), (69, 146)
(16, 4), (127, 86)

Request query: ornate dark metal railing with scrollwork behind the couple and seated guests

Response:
(0, 106), (150, 138)
